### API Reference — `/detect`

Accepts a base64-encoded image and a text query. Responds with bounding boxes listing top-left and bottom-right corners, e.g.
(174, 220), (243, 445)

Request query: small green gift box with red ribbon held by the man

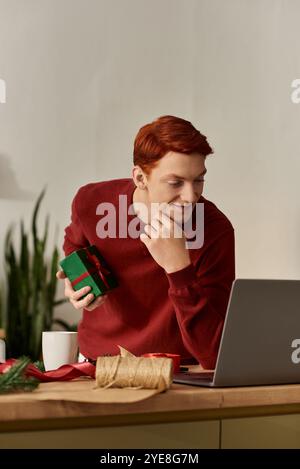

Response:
(59, 245), (118, 301)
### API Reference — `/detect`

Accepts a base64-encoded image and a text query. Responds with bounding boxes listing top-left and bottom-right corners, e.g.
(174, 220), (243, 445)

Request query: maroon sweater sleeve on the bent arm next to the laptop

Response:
(166, 227), (235, 369)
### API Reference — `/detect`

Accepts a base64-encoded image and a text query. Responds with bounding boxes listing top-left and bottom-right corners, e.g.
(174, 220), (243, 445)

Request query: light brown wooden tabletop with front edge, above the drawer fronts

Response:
(0, 366), (300, 432)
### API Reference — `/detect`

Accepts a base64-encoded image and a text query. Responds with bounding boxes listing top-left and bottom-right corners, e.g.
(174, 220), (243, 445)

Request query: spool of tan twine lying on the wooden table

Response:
(96, 353), (173, 392)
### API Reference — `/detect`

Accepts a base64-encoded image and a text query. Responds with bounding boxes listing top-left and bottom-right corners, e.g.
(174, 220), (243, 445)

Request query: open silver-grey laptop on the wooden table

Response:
(173, 279), (300, 387)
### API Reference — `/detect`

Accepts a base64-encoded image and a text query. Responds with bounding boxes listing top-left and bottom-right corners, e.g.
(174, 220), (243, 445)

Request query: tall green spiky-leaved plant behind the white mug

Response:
(2, 189), (68, 361)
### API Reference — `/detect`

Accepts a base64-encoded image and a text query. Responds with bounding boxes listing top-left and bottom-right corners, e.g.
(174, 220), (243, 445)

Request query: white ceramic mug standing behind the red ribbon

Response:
(42, 331), (78, 371)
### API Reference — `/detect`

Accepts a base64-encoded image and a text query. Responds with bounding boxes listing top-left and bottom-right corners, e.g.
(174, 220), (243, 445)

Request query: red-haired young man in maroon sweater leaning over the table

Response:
(57, 116), (235, 369)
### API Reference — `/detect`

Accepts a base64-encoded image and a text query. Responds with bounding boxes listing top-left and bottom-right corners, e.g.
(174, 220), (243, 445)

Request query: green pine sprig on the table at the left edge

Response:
(0, 357), (39, 394)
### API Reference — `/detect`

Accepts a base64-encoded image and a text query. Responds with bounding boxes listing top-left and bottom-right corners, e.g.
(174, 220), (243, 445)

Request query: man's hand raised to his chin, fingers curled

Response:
(140, 206), (191, 273)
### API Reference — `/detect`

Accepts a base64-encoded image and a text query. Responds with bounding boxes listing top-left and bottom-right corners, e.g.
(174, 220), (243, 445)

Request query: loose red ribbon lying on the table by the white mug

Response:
(0, 358), (96, 383)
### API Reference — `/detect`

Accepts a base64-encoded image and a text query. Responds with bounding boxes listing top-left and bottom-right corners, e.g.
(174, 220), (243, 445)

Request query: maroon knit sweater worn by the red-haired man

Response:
(63, 179), (235, 369)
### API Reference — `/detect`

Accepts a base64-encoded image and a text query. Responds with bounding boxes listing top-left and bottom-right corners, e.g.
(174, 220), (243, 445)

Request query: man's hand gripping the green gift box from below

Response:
(56, 270), (107, 311)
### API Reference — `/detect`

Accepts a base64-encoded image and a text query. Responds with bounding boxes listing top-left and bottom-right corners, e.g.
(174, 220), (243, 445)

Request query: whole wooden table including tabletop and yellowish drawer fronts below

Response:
(0, 366), (300, 448)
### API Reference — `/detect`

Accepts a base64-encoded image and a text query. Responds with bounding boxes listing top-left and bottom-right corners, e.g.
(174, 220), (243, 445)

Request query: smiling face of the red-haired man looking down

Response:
(141, 152), (207, 220)
